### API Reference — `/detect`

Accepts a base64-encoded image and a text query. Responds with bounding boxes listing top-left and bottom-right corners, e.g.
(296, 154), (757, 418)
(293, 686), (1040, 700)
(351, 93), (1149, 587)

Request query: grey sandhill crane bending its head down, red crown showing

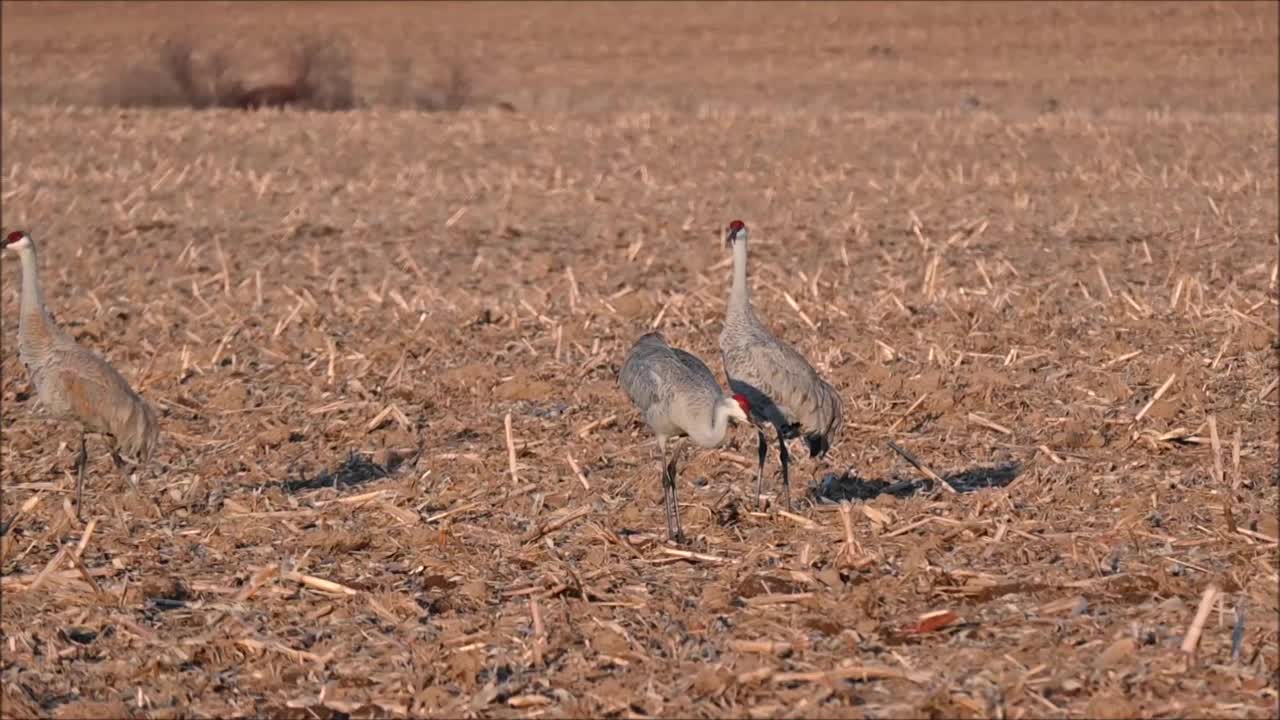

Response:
(618, 332), (750, 542)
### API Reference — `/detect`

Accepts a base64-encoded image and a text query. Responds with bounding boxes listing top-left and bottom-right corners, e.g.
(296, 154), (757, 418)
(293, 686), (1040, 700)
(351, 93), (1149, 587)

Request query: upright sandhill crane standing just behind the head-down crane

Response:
(719, 220), (845, 510)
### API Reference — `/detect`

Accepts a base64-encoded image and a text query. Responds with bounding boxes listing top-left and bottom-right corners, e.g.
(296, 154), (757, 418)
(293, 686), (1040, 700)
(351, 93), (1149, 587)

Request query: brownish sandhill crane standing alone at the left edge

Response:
(4, 231), (160, 516)
